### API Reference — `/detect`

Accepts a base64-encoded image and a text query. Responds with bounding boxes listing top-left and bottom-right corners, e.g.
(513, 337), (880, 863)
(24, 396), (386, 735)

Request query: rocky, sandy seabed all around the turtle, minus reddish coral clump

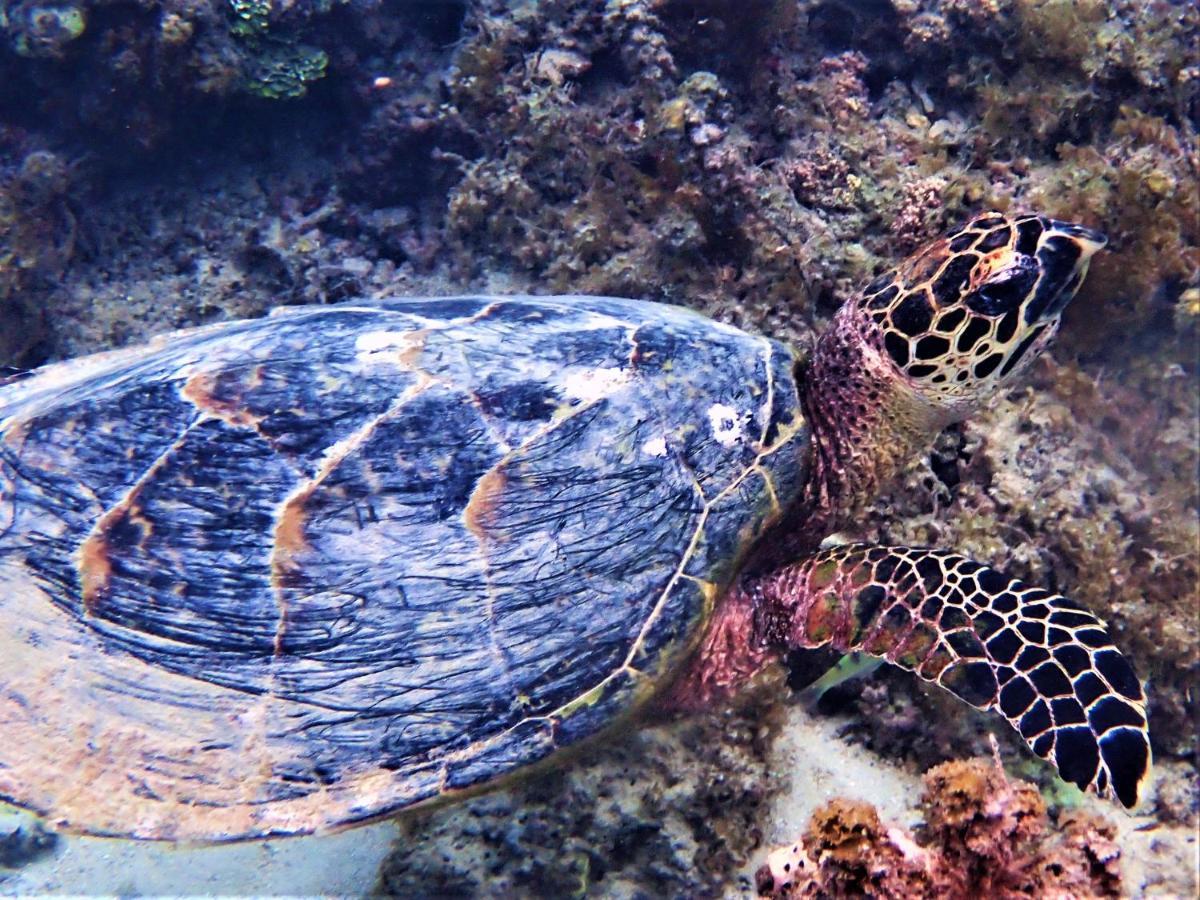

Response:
(0, 0), (1200, 898)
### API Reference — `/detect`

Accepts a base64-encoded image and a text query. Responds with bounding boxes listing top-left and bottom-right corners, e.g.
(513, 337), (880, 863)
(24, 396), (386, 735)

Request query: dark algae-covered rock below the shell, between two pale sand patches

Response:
(376, 692), (780, 898)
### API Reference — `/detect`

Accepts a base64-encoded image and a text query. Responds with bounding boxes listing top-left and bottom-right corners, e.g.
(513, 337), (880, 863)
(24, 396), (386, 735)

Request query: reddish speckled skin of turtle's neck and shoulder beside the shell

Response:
(662, 302), (966, 710)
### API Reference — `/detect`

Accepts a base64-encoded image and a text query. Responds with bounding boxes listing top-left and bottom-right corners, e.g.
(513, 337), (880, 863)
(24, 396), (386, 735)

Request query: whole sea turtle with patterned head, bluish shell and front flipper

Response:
(0, 214), (1150, 840)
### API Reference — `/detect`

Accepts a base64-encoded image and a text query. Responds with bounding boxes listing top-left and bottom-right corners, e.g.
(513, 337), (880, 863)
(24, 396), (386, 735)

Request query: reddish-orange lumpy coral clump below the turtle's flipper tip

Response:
(756, 760), (1122, 900)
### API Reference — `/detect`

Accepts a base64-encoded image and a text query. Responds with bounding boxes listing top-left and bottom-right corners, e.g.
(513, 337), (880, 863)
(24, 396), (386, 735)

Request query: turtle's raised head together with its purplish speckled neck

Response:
(798, 212), (1105, 542)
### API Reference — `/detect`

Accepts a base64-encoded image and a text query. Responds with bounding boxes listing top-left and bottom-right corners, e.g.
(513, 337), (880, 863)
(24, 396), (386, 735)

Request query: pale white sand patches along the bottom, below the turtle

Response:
(0, 708), (1196, 898)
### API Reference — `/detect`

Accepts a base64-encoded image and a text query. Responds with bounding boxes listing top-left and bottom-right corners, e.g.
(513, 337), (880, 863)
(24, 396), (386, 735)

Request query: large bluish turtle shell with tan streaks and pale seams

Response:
(0, 296), (808, 840)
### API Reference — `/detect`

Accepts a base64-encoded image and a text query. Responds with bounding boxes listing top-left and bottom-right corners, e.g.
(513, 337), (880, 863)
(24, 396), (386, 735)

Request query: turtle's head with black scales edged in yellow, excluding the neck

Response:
(858, 212), (1105, 403)
